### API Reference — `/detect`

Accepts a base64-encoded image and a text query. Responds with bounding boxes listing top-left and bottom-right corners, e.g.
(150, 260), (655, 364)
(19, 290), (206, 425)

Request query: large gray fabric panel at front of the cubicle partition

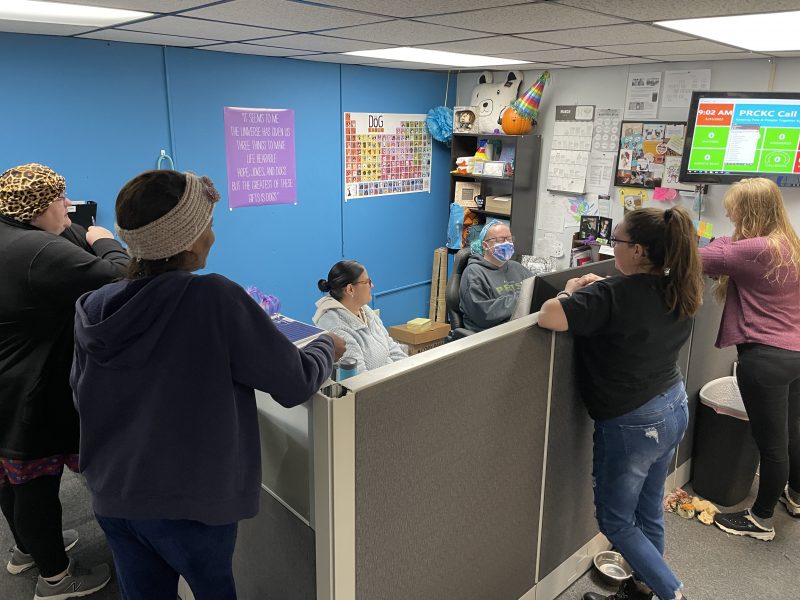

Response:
(355, 328), (551, 600)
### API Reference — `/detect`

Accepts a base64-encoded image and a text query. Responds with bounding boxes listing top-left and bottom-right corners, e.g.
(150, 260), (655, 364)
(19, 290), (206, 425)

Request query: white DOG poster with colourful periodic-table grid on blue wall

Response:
(343, 113), (433, 202)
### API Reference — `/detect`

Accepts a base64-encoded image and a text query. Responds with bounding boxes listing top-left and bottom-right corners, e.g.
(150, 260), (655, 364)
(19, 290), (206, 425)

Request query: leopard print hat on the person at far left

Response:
(0, 163), (67, 222)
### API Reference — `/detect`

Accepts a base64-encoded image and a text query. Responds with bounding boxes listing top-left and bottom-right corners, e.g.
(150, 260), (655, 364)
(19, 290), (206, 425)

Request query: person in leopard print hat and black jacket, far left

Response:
(0, 163), (128, 598)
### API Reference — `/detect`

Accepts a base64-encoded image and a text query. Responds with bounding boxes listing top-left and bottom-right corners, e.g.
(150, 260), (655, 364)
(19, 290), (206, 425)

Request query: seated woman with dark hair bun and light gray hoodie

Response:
(313, 260), (408, 373)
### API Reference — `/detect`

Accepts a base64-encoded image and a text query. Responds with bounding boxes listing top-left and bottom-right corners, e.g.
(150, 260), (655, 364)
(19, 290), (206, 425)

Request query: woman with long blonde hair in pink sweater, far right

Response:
(700, 178), (800, 540)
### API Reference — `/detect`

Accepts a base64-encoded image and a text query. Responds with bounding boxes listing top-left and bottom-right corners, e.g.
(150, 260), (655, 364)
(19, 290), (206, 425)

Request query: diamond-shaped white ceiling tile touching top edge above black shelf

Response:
(420, 2), (623, 34)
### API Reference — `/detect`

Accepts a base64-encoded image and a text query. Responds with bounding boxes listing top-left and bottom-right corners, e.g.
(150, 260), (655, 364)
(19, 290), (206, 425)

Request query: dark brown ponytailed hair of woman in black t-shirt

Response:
(625, 206), (703, 317)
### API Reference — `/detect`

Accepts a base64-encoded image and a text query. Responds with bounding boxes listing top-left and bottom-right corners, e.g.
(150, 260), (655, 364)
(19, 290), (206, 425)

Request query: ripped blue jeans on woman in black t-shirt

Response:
(592, 382), (689, 600)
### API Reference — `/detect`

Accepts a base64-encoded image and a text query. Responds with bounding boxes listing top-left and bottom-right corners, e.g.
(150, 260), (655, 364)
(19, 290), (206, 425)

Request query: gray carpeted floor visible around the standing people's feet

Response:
(0, 473), (800, 600)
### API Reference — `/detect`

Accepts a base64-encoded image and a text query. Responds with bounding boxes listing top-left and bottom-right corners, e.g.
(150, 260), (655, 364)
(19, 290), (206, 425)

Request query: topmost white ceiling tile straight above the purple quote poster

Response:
(184, 0), (394, 31)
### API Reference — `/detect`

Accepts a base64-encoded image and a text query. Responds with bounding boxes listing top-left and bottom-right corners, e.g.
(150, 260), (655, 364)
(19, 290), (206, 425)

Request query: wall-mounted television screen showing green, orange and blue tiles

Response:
(680, 91), (800, 183)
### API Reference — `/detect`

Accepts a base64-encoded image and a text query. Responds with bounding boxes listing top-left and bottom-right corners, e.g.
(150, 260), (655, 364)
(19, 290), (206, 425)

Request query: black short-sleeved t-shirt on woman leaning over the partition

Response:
(561, 274), (692, 420)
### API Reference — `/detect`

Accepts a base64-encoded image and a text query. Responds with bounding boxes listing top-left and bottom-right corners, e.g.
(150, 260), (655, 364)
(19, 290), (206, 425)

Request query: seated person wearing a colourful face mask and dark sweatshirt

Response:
(459, 219), (533, 331)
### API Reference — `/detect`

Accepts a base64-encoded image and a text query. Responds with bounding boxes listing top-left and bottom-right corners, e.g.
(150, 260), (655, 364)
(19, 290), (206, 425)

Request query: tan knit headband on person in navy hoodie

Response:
(116, 172), (219, 260)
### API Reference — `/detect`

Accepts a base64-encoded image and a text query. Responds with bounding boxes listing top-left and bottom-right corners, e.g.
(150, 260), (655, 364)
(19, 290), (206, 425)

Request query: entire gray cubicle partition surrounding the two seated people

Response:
(235, 284), (731, 600)
